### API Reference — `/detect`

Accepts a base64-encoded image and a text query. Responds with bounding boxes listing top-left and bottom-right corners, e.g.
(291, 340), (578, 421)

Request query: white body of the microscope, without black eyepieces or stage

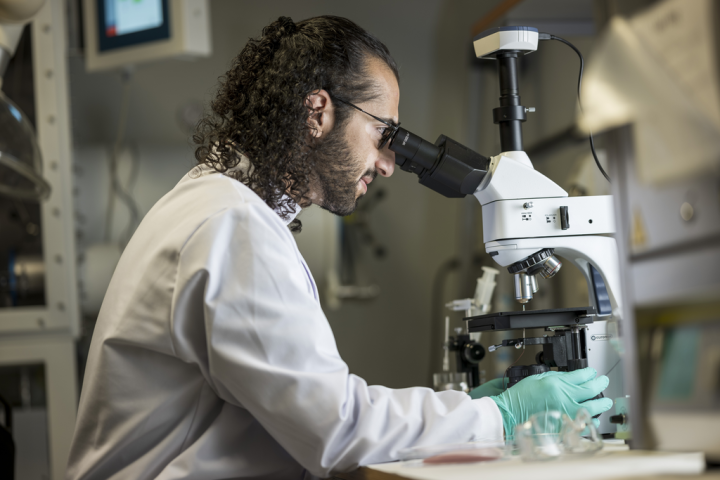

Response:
(474, 151), (623, 433)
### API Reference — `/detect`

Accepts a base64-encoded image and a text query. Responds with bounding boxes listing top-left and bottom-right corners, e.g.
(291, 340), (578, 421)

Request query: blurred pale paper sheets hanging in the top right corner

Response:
(578, 0), (720, 185)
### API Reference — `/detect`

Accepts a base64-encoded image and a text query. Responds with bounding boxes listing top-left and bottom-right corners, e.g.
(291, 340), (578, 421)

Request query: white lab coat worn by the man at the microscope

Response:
(67, 168), (502, 480)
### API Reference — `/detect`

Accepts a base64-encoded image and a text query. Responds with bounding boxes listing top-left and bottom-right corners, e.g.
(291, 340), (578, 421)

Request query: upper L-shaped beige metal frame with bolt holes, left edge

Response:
(0, 0), (80, 337)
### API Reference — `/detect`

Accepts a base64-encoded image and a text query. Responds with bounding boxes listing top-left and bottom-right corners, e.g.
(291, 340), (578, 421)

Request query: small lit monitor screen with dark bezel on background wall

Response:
(97, 0), (170, 52)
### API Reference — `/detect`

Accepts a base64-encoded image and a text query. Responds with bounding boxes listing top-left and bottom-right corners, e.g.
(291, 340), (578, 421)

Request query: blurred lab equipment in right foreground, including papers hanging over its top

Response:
(578, 0), (720, 462)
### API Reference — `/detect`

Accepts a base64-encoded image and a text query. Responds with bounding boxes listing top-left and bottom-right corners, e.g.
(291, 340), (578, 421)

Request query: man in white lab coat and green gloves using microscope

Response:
(68, 17), (612, 480)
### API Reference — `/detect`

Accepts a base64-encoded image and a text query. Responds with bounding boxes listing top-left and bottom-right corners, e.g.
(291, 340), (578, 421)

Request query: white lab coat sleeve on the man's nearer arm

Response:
(173, 204), (502, 477)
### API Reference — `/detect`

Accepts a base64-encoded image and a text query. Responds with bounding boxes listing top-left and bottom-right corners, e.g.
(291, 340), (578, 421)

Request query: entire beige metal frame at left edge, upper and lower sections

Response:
(0, 0), (80, 480)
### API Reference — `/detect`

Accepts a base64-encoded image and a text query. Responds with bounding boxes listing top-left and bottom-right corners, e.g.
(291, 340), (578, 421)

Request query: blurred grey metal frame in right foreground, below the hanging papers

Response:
(603, 125), (720, 454)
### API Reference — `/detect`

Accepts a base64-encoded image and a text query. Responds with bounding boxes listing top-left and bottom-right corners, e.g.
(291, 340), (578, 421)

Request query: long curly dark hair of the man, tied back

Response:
(193, 16), (399, 231)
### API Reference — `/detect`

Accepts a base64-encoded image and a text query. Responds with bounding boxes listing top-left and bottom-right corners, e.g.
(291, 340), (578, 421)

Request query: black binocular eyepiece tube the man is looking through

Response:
(388, 127), (490, 198)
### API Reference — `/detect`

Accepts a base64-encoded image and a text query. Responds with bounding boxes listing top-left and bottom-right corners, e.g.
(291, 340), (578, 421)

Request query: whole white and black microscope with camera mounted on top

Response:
(389, 26), (624, 434)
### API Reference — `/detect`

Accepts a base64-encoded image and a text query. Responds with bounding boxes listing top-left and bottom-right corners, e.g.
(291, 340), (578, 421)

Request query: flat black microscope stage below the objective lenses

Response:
(463, 307), (595, 333)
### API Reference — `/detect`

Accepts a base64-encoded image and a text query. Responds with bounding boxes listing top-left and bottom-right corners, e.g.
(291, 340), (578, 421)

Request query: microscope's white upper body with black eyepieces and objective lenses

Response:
(389, 128), (622, 318)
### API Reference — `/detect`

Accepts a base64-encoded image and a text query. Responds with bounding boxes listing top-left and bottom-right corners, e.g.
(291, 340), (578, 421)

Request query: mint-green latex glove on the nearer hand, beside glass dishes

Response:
(490, 368), (613, 436)
